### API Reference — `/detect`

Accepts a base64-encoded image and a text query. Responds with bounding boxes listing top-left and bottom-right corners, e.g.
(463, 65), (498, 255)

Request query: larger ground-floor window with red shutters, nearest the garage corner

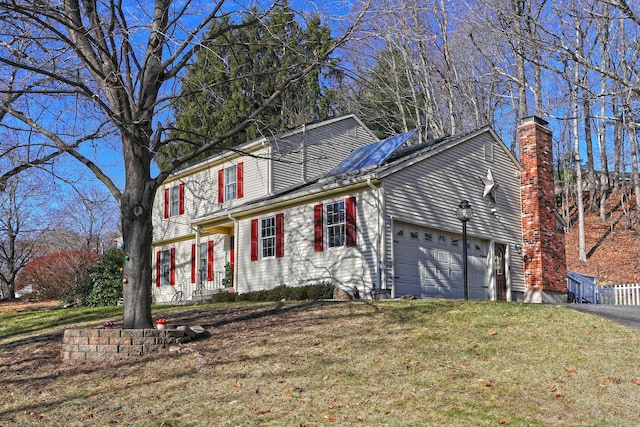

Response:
(313, 197), (357, 252)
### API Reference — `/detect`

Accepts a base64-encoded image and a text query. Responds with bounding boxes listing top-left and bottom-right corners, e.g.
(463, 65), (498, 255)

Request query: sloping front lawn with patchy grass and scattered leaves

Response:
(0, 301), (640, 426)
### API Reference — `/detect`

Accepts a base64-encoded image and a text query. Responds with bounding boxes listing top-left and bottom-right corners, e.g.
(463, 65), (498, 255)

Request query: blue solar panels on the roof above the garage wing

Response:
(325, 129), (417, 178)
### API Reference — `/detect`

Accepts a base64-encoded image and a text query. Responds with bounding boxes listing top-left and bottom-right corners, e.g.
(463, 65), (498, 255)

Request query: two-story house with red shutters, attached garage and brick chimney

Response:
(153, 115), (566, 303)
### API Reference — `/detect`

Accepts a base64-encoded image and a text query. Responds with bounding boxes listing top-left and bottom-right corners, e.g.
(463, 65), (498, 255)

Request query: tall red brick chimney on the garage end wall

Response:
(518, 116), (567, 303)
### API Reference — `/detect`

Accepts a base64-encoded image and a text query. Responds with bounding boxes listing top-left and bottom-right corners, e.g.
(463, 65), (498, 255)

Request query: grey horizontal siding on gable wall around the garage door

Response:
(383, 132), (523, 290)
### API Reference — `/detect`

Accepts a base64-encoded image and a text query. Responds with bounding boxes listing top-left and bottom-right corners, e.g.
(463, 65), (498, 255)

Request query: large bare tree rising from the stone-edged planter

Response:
(0, 0), (366, 328)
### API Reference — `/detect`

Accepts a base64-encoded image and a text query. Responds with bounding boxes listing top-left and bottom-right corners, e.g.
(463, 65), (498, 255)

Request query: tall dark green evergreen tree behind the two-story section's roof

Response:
(158, 2), (337, 169)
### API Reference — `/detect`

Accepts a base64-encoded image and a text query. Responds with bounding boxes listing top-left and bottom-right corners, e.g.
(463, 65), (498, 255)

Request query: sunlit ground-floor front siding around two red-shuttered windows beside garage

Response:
(236, 191), (380, 296)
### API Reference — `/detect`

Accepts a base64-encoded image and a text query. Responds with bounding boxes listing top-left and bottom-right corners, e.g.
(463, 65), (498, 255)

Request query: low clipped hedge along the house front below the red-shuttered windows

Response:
(211, 283), (335, 302)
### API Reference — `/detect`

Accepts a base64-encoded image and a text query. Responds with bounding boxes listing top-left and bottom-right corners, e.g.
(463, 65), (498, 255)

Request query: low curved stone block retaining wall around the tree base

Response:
(62, 329), (193, 360)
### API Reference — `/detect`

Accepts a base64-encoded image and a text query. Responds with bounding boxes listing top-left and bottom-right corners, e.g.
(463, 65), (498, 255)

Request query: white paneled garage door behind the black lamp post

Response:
(394, 223), (489, 299)
